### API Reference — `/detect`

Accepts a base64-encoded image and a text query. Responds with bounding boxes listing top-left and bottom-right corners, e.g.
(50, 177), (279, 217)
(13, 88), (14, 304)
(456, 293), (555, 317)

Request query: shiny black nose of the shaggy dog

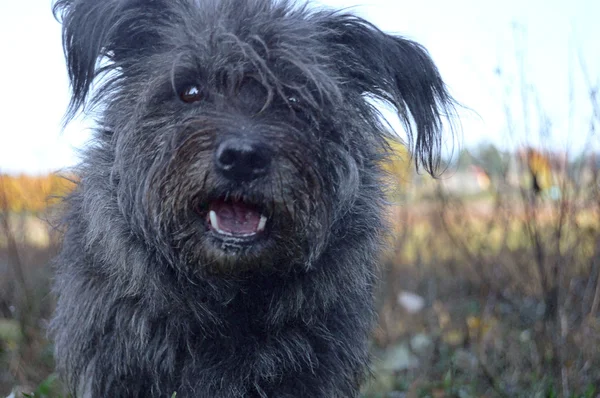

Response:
(215, 138), (271, 181)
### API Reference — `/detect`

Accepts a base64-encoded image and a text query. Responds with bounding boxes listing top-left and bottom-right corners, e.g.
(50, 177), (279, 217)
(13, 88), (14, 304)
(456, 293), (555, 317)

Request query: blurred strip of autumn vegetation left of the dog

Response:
(0, 174), (73, 397)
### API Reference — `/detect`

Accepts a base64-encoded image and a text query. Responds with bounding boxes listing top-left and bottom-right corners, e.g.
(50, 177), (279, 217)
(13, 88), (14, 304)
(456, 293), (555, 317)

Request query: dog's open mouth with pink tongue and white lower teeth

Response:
(207, 199), (267, 239)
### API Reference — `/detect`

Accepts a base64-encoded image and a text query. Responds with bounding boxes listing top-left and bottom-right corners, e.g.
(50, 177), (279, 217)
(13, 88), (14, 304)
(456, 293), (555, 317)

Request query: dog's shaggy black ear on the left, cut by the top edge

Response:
(53, 0), (159, 120)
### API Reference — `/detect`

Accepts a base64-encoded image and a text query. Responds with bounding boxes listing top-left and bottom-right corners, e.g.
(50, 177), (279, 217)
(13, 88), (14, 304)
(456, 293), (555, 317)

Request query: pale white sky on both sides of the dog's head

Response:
(0, 0), (600, 173)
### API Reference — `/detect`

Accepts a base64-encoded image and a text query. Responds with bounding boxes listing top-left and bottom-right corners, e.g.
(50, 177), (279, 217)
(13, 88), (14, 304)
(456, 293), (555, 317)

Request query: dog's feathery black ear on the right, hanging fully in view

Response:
(325, 15), (454, 174)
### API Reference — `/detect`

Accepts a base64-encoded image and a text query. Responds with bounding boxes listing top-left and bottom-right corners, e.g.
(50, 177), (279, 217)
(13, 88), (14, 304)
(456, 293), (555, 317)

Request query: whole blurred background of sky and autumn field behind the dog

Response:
(0, 0), (600, 398)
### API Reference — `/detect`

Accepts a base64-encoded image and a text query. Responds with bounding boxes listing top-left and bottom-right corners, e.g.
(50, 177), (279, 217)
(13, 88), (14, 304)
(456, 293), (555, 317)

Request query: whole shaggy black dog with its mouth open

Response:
(52, 0), (452, 398)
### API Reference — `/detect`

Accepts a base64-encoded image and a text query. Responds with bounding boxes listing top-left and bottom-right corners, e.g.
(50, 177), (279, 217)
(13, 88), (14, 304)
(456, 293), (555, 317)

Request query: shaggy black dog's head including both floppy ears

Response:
(55, 0), (451, 272)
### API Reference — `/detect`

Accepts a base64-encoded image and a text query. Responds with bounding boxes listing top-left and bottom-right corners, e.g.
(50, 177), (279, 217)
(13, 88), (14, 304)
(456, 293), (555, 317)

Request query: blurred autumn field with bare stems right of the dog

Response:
(365, 141), (600, 397)
